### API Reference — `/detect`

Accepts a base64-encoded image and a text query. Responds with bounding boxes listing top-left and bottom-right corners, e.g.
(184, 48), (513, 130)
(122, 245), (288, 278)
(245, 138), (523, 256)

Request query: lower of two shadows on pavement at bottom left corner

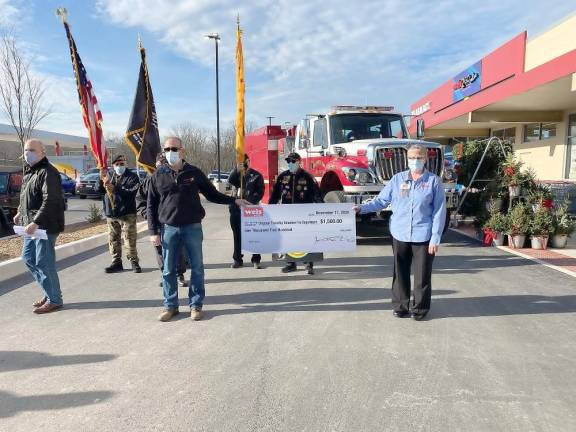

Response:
(0, 391), (114, 418)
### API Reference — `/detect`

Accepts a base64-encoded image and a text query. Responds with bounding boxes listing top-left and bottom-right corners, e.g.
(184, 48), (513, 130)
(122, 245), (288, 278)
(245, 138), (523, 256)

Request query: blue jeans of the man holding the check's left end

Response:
(162, 223), (204, 309)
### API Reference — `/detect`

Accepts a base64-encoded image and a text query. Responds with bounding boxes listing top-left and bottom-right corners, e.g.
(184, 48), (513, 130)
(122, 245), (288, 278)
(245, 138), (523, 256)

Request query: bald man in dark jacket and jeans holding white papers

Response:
(14, 140), (64, 314)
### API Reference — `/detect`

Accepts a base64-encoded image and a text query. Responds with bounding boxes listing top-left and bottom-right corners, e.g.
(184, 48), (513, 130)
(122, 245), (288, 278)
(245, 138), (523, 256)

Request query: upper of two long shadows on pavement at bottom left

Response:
(0, 351), (117, 373)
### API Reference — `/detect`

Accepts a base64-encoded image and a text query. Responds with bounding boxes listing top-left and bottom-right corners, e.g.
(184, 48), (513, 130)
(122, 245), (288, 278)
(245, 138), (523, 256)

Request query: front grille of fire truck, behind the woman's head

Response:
(375, 147), (442, 181)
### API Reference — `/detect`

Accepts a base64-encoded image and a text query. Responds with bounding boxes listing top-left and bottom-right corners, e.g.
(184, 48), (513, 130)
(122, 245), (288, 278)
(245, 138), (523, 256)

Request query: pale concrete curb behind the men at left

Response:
(0, 221), (148, 281)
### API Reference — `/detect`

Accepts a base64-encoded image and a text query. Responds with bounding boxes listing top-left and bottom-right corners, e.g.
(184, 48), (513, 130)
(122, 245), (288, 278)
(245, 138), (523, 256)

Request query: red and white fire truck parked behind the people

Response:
(245, 106), (458, 226)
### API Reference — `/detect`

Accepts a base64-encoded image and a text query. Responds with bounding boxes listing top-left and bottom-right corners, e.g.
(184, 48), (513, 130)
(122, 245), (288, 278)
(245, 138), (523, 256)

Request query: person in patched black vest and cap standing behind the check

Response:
(268, 152), (323, 275)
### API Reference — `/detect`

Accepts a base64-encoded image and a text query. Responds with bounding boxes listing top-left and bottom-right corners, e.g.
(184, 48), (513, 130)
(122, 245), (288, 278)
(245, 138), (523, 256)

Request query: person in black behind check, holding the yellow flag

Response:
(228, 155), (264, 269)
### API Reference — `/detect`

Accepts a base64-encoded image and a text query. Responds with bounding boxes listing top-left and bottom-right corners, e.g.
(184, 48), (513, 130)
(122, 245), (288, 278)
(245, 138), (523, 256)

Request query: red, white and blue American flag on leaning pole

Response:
(64, 22), (108, 168)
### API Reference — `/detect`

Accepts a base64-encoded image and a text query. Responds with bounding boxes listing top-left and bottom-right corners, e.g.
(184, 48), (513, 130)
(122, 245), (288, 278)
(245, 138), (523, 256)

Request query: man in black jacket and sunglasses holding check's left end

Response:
(147, 137), (249, 321)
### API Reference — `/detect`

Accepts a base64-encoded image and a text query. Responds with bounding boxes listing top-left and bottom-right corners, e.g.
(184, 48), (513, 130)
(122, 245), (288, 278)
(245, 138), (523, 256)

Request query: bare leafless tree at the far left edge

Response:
(0, 32), (51, 162)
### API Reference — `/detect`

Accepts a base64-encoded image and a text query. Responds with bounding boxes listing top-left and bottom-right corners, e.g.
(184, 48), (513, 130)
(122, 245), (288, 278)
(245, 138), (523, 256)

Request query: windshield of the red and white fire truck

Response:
(330, 113), (408, 144)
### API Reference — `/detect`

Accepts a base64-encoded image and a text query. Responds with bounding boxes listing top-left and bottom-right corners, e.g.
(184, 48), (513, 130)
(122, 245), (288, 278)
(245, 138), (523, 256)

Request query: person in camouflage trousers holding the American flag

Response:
(100, 155), (142, 273)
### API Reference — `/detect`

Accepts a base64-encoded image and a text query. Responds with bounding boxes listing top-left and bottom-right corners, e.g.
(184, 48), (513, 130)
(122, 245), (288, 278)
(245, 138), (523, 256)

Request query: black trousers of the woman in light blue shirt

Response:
(392, 238), (434, 314)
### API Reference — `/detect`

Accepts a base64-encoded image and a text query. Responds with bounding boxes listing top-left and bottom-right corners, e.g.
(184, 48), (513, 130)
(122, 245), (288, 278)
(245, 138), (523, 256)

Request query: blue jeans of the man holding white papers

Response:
(22, 234), (62, 305)
